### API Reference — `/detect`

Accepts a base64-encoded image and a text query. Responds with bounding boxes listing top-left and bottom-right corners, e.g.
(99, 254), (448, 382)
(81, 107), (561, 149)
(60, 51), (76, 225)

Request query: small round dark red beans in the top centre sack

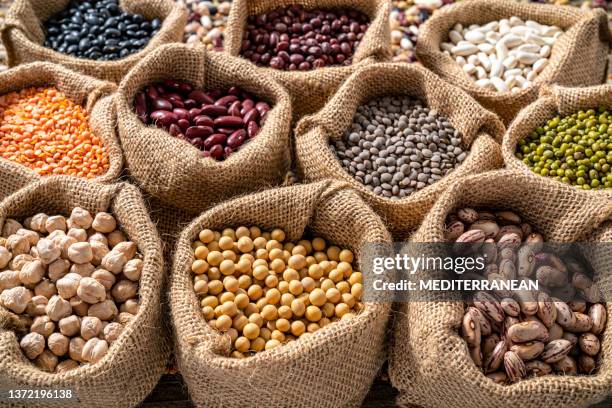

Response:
(241, 5), (369, 71)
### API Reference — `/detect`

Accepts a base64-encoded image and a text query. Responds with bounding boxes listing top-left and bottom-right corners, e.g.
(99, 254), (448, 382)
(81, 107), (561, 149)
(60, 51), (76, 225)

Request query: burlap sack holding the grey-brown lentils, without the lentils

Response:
(295, 63), (504, 240)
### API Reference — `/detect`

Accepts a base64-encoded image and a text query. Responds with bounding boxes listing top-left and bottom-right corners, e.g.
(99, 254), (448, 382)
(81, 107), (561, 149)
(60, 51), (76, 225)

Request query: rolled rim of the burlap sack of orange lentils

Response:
(0, 62), (123, 183)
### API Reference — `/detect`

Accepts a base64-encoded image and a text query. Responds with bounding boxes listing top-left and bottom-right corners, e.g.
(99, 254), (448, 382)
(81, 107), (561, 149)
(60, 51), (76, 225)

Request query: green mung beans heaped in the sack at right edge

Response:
(516, 107), (612, 190)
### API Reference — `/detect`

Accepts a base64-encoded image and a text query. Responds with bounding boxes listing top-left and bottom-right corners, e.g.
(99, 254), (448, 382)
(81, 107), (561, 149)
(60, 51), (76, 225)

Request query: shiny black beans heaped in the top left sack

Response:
(44, 0), (161, 61)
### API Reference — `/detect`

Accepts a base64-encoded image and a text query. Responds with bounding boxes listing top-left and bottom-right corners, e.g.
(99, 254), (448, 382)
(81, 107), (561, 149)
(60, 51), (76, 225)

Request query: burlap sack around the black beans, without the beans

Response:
(0, 0), (187, 82)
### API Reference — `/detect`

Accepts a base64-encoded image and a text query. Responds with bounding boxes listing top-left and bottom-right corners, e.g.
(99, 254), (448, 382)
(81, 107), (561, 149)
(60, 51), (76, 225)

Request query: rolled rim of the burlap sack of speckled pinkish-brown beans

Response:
(396, 170), (612, 403)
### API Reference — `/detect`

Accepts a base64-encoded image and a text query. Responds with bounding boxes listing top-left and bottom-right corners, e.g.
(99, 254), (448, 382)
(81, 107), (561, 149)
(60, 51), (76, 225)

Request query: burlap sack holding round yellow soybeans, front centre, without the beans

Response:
(170, 181), (391, 408)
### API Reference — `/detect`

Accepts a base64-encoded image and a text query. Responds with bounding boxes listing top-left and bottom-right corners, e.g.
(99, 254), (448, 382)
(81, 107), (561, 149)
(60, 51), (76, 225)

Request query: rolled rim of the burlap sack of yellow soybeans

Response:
(171, 180), (390, 364)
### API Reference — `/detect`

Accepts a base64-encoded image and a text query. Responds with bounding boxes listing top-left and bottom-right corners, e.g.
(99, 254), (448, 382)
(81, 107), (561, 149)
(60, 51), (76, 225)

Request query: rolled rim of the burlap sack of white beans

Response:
(416, 0), (612, 99)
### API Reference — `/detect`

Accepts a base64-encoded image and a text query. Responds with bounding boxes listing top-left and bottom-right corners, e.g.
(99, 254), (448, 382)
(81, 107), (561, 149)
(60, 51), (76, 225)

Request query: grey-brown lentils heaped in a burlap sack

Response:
(331, 96), (467, 199)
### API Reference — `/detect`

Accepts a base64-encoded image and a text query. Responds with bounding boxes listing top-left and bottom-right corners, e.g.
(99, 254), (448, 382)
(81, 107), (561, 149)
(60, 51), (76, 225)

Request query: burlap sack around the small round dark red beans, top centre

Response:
(224, 0), (391, 119)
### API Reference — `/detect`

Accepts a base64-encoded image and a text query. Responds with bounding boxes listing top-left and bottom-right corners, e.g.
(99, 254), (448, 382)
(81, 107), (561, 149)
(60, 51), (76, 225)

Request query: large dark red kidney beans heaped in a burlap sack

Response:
(134, 80), (270, 160)
